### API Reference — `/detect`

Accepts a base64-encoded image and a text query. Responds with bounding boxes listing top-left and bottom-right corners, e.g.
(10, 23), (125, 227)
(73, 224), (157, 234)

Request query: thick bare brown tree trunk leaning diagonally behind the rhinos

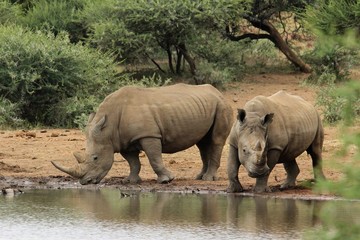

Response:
(247, 18), (312, 73)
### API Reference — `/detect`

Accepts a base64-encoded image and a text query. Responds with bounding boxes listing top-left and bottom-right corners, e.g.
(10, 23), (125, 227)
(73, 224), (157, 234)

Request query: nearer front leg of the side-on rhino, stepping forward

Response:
(139, 138), (174, 183)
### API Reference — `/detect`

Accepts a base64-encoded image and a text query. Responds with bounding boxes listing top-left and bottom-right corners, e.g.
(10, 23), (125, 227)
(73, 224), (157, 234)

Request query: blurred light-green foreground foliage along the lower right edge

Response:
(305, 80), (360, 240)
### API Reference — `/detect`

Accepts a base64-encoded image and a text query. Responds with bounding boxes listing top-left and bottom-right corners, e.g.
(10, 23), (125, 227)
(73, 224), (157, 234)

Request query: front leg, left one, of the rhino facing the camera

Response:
(227, 145), (243, 193)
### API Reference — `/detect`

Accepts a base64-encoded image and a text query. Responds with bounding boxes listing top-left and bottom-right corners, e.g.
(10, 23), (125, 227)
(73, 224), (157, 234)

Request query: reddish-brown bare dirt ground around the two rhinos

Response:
(0, 73), (354, 198)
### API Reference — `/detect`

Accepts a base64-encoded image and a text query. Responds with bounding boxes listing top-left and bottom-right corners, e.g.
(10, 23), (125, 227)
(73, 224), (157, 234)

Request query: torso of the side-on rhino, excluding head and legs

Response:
(98, 84), (231, 153)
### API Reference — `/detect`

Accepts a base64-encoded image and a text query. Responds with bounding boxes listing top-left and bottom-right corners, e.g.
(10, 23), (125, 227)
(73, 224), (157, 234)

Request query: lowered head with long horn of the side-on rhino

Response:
(52, 114), (114, 184)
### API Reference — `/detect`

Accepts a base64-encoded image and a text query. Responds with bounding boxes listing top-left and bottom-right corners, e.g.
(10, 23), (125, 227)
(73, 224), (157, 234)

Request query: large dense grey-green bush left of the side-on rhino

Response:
(0, 25), (119, 126)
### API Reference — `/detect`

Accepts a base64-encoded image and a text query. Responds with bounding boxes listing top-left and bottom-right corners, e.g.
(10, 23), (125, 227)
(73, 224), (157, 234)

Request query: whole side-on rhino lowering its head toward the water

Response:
(52, 84), (233, 184)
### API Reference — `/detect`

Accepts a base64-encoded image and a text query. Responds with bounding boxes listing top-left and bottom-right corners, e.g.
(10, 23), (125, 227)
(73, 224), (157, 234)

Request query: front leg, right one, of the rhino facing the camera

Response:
(253, 150), (281, 193)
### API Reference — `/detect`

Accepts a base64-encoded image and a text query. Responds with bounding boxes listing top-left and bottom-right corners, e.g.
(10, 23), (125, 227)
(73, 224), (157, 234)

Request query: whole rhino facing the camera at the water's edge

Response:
(227, 91), (324, 192)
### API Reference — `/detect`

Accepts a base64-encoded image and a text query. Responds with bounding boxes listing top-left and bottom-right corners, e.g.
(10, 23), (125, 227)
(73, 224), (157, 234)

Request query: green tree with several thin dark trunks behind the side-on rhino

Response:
(119, 0), (248, 75)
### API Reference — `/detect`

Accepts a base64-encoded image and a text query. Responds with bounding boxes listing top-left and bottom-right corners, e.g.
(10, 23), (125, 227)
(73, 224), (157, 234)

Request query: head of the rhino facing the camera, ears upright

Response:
(237, 109), (274, 177)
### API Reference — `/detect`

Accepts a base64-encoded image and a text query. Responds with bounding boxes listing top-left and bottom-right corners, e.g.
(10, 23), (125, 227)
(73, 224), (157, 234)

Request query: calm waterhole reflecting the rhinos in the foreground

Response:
(0, 189), (360, 240)
